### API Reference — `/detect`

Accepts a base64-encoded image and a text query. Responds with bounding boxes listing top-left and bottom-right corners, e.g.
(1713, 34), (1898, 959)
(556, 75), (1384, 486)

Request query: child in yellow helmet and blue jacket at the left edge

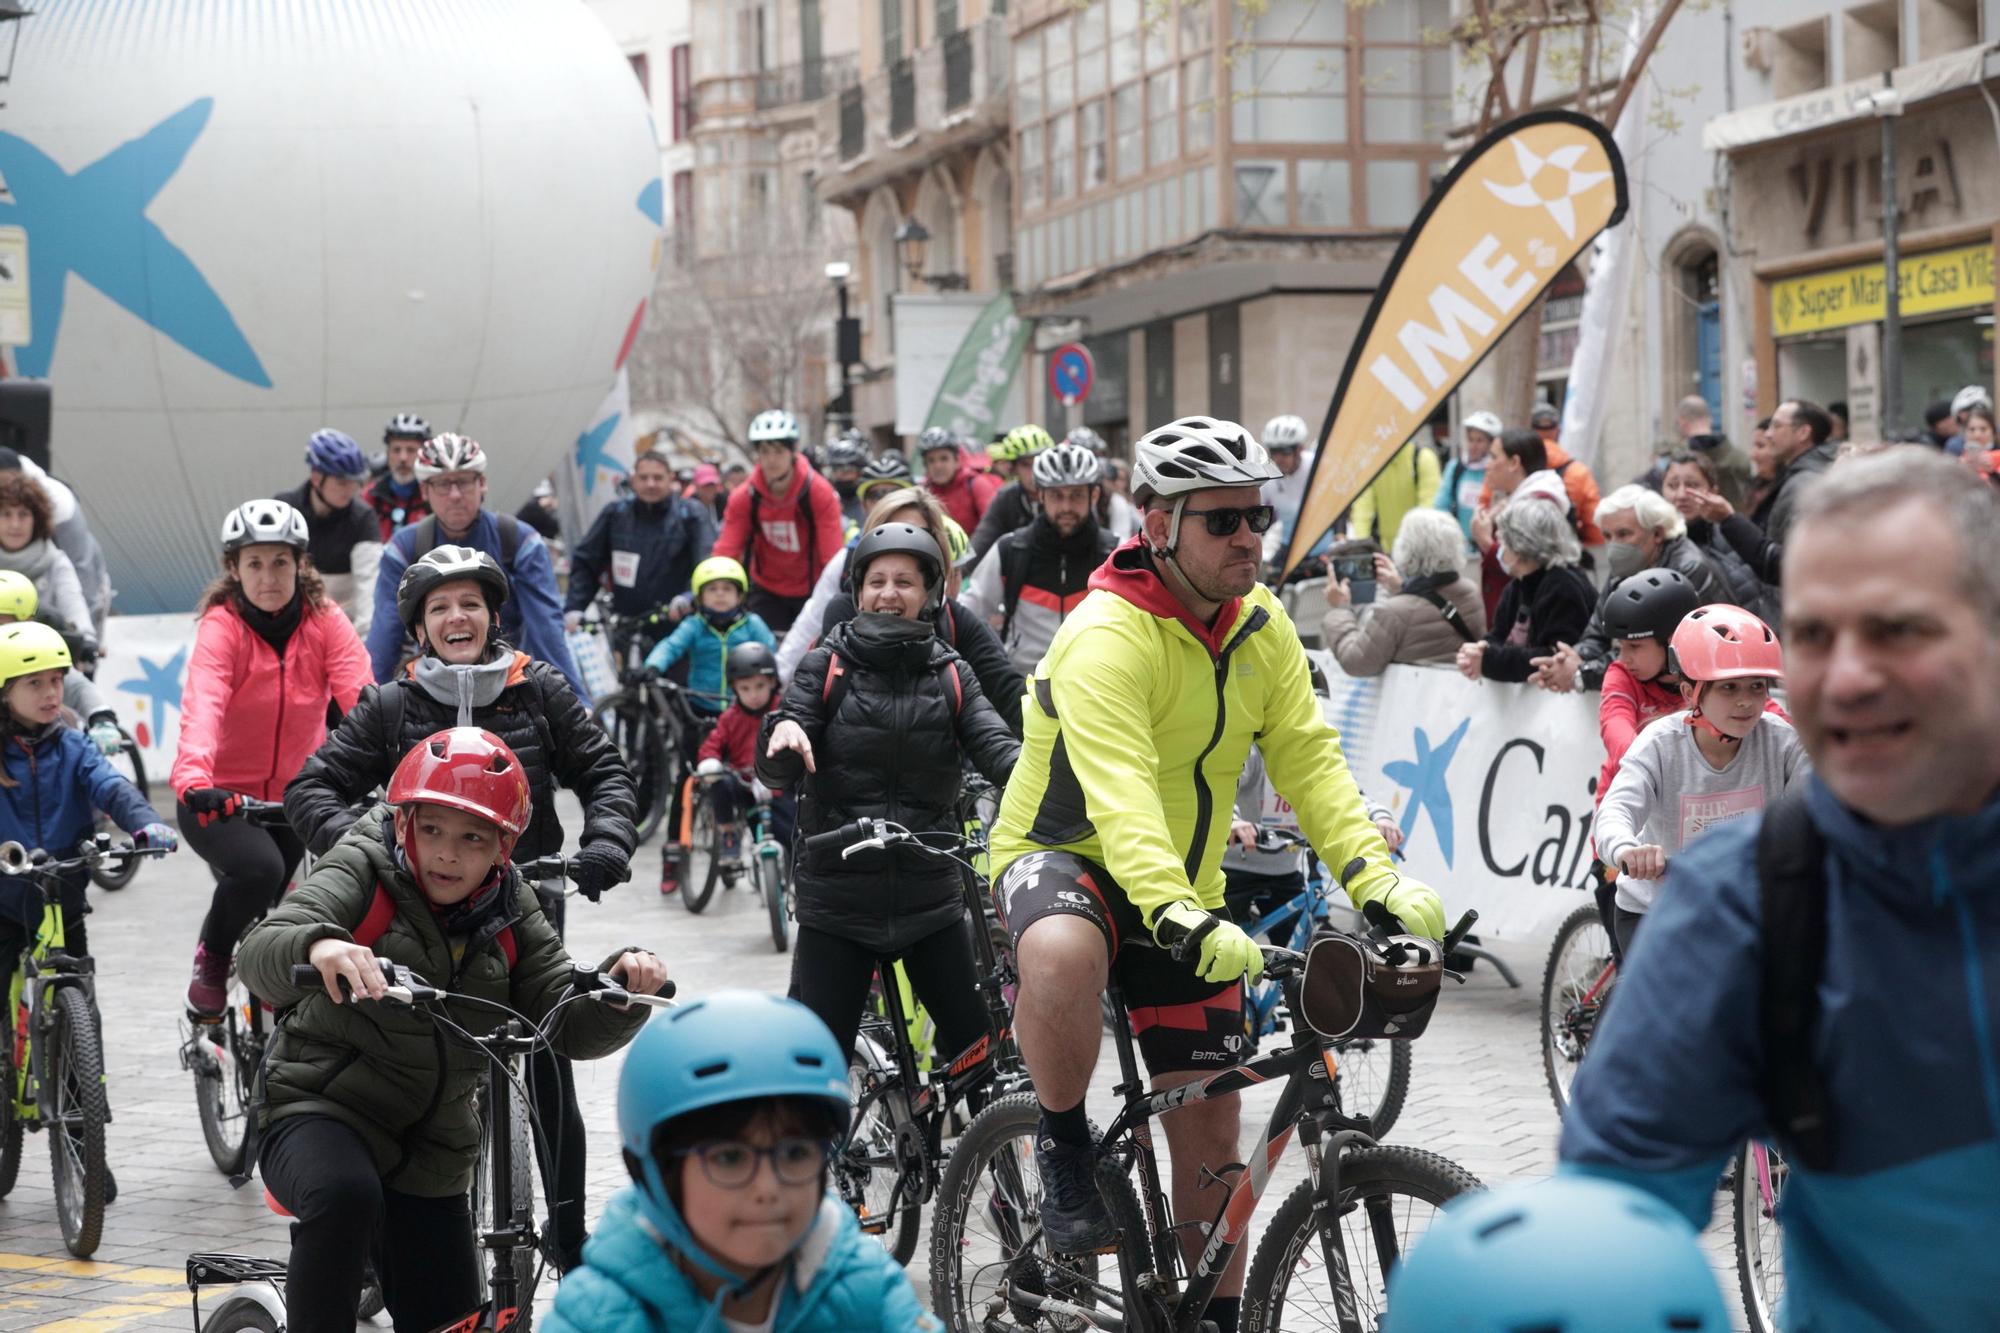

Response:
(0, 620), (180, 991)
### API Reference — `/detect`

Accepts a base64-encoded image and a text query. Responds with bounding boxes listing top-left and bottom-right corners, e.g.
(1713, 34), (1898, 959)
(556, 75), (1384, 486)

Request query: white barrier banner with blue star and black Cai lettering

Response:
(1312, 652), (1604, 939)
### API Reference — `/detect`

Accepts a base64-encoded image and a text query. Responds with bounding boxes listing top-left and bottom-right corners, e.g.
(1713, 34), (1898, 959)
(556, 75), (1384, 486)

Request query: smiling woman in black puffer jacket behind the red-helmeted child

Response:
(284, 546), (638, 1271)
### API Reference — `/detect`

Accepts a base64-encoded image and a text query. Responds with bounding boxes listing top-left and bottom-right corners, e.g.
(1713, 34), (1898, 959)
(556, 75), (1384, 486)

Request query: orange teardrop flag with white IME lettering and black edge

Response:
(1284, 110), (1626, 570)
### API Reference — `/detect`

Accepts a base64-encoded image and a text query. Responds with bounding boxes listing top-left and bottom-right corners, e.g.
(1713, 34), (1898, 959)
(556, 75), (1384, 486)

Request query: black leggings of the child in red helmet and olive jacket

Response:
(258, 1115), (484, 1333)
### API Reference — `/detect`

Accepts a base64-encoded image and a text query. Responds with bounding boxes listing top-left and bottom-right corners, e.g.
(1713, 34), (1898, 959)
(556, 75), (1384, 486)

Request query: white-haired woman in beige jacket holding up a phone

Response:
(1322, 508), (1486, 677)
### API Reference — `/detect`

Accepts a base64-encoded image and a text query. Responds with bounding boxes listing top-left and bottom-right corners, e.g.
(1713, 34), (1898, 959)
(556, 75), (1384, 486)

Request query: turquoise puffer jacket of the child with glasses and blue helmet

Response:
(542, 1185), (942, 1333)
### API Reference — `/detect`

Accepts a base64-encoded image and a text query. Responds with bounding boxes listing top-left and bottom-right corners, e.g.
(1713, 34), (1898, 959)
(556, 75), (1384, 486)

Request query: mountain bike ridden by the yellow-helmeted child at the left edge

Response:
(0, 833), (166, 1259)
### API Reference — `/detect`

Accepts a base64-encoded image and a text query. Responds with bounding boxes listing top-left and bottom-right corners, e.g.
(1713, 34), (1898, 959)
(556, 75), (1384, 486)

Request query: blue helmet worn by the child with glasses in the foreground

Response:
(618, 991), (854, 1283)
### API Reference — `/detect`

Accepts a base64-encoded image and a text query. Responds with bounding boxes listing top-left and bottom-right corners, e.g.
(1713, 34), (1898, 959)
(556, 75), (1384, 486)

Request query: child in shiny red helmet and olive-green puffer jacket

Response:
(236, 727), (666, 1333)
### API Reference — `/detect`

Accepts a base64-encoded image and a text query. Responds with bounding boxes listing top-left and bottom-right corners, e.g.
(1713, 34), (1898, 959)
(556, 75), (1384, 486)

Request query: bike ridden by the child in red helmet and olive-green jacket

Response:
(186, 959), (674, 1333)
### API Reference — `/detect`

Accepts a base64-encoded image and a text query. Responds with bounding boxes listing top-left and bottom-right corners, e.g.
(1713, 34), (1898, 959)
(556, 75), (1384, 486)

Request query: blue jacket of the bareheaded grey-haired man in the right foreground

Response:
(1562, 779), (2000, 1333)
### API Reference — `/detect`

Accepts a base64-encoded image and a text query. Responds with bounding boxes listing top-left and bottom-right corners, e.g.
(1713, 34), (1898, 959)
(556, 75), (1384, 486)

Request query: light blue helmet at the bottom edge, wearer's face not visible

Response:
(1382, 1175), (1730, 1333)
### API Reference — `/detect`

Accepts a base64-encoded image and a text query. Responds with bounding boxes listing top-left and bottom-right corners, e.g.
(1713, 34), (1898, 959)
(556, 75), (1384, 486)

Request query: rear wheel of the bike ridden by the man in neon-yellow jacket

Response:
(930, 1093), (1152, 1333)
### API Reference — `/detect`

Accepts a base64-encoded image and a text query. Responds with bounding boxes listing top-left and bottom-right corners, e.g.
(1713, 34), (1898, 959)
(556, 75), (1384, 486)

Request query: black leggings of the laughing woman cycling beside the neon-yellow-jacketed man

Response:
(792, 921), (990, 1059)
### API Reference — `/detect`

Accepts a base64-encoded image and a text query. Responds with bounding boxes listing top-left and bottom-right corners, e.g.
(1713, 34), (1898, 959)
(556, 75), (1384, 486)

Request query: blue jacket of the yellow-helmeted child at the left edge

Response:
(0, 723), (162, 925)
